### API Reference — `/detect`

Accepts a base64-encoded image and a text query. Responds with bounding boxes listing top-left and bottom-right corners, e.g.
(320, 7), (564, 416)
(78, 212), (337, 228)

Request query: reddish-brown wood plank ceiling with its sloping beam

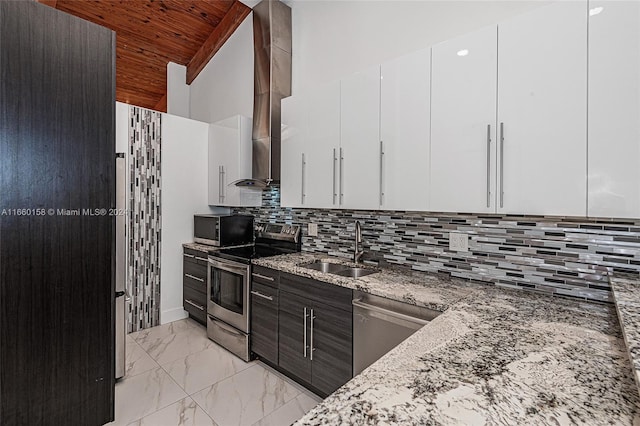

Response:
(38, 0), (251, 112)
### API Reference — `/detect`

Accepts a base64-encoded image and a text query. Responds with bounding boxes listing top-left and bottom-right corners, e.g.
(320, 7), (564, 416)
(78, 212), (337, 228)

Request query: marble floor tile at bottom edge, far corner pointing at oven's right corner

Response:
(192, 364), (300, 426)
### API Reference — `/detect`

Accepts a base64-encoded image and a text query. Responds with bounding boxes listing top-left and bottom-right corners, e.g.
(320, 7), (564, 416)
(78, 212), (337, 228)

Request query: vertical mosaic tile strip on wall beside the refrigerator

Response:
(126, 107), (162, 333)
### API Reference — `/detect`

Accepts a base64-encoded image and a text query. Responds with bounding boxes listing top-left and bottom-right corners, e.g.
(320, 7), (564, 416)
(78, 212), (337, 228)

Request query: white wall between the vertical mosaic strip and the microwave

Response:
(160, 114), (228, 324)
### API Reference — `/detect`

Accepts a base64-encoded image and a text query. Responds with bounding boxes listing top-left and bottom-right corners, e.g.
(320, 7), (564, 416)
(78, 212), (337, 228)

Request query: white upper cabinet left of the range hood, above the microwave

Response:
(209, 115), (262, 207)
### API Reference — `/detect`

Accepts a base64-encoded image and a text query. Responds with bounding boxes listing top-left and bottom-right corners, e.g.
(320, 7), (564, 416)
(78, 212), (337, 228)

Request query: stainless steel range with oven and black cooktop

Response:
(207, 224), (301, 361)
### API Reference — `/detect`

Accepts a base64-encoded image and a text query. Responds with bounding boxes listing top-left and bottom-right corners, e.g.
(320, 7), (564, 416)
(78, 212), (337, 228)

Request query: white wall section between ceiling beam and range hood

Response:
(190, 14), (253, 123)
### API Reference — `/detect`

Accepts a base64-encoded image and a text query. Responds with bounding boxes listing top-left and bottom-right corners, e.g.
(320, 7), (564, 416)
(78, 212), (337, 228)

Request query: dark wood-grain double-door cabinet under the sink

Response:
(278, 274), (353, 396)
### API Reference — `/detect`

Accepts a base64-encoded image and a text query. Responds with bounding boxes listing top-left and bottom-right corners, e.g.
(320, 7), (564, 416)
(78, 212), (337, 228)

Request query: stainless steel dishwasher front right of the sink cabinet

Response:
(352, 291), (440, 376)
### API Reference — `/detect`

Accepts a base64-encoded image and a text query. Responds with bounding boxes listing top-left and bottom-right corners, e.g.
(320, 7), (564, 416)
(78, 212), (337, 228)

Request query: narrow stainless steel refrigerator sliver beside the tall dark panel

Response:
(115, 153), (127, 379)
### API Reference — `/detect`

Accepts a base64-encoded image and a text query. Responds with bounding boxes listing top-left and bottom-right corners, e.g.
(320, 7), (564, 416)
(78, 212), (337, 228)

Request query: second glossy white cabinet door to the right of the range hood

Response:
(303, 81), (340, 208)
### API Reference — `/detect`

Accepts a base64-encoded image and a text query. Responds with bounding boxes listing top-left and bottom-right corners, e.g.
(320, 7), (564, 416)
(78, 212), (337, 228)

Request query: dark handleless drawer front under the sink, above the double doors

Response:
(280, 272), (353, 312)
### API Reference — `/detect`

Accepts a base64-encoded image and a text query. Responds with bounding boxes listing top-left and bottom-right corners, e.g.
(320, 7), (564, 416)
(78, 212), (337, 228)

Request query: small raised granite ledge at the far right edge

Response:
(609, 274), (640, 396)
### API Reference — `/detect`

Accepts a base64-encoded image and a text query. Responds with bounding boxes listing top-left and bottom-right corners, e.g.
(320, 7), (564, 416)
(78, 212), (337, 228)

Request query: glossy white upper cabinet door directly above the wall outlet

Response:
(430, 26), (498, 213)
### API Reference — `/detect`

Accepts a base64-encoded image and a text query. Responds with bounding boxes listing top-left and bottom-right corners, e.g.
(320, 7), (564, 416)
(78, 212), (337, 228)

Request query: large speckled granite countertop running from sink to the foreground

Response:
(255, 254), (640, 425)
